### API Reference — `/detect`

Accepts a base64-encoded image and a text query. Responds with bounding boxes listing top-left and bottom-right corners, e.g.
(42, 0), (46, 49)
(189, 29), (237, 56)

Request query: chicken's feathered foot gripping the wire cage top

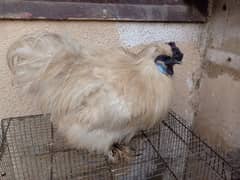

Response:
(108, 143), (135, 163)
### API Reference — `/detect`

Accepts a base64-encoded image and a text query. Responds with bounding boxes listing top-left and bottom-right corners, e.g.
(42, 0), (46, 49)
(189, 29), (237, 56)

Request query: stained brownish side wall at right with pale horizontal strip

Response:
(195, 0), (240, 151)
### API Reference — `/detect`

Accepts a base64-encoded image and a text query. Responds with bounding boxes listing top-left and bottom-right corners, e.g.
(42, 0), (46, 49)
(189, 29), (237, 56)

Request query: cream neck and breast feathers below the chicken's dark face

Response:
(127, 61), (173, 128)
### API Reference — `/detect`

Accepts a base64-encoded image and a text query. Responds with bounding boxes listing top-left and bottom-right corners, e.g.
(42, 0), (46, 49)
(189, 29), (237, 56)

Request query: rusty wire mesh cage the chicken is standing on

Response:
(0, 112), (240, 180)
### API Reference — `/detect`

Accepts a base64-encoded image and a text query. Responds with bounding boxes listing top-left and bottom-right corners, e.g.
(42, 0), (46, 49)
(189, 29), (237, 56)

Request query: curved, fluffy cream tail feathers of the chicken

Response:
(7, 32), (80, 93)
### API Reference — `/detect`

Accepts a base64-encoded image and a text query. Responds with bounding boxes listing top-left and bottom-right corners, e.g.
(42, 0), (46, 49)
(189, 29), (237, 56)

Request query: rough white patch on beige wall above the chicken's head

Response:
(117, 23), (204, 47)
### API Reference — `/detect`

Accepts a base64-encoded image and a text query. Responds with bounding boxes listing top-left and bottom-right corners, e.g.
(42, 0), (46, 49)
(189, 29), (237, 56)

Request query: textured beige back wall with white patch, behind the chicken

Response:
(0, 21), (204, 121)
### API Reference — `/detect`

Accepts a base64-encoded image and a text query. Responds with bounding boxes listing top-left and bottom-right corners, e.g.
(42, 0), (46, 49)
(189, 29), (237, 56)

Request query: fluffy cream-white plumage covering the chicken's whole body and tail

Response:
(7, 33), (178, 162)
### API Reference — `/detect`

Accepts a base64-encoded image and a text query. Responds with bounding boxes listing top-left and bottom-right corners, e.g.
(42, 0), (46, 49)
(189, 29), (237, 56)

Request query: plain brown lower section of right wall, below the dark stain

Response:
(195, 74), (240, 150)
